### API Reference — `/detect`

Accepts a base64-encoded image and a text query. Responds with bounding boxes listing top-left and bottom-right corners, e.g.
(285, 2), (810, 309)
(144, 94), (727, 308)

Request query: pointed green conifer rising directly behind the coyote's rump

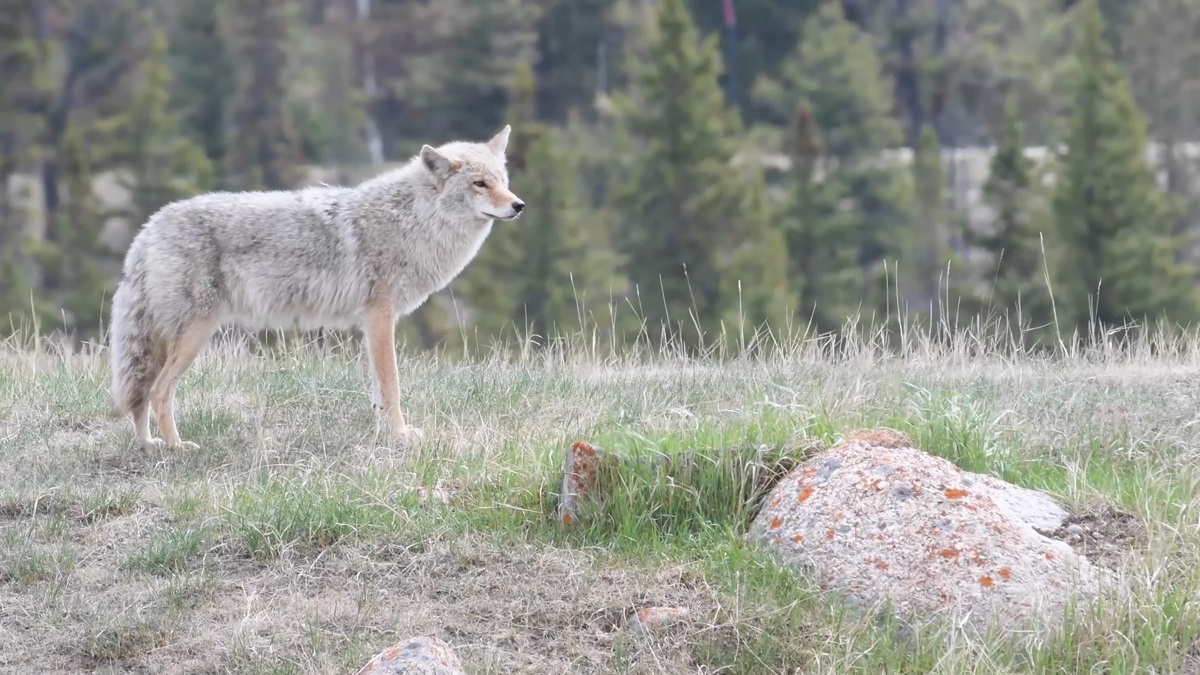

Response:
(113, 32), (212, 223)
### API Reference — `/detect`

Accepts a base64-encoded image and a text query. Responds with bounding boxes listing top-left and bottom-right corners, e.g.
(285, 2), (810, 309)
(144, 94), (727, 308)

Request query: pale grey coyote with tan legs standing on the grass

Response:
(110, 125), (524, 449)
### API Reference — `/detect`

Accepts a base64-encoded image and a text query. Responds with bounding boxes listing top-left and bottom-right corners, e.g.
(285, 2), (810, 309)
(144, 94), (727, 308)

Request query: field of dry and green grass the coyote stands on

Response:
(0, 319), (1200, 674)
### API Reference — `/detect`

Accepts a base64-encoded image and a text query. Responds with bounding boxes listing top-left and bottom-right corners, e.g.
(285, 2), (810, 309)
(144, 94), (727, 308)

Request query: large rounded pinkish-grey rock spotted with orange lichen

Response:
(746, 430), (1097, 629)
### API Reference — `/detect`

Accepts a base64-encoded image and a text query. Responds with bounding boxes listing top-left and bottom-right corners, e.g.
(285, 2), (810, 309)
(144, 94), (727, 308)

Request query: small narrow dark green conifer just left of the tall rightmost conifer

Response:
(971, 98), (1051, 325)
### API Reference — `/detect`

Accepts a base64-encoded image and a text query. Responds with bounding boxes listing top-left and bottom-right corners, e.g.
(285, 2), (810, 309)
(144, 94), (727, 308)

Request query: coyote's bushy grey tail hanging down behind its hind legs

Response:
(109, 243), (163, 414)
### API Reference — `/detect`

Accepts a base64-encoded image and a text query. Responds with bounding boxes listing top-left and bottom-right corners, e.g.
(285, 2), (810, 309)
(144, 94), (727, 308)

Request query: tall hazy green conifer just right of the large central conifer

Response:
(754, 0), (913, 330)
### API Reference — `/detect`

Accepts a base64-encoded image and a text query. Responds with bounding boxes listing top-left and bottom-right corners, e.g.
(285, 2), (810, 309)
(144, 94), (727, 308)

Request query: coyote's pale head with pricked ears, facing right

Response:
(421, 125), (524, 220)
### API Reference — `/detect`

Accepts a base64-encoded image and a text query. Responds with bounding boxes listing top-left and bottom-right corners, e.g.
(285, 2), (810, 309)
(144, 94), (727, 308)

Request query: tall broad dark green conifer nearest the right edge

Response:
(1054, 0), (1198, 335)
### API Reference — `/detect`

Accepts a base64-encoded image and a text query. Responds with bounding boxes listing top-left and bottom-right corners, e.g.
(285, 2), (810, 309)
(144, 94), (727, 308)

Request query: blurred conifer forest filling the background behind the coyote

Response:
(0, 0), (1200, 350)
